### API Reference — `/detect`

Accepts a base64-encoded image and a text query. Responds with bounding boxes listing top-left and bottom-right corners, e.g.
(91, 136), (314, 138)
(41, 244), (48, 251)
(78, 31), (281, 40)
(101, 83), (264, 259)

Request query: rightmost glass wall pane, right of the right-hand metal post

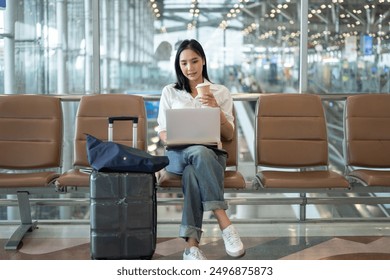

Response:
(308, 0), (390, 94)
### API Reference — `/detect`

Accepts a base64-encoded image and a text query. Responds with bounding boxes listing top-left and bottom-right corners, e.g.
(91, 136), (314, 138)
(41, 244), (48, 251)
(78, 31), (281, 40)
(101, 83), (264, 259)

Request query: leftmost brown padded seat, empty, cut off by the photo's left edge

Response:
(0, 94), (62, 188)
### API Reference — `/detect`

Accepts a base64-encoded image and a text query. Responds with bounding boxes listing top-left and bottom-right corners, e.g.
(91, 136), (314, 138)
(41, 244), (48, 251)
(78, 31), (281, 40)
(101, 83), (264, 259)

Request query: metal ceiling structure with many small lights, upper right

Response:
(149, 0), (390, 47)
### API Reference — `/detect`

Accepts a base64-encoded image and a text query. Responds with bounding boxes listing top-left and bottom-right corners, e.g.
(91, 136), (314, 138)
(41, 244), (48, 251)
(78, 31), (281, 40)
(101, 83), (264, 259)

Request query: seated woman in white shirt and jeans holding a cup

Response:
(157, 40), (245, 260)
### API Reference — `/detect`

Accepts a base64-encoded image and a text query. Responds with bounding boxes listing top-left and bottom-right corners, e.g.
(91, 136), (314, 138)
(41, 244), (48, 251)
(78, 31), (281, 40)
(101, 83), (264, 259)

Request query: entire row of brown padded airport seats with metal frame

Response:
(0, 94), (390, 250)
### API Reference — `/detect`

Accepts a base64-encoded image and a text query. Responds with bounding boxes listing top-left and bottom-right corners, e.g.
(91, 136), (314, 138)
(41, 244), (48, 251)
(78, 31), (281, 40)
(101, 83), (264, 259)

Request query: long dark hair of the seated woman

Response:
(175, 39), (210, 93)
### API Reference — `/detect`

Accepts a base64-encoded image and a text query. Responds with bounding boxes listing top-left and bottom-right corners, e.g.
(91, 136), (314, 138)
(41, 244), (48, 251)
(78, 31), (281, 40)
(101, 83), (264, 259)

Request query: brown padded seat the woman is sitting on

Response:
(157, 108), (246, 189)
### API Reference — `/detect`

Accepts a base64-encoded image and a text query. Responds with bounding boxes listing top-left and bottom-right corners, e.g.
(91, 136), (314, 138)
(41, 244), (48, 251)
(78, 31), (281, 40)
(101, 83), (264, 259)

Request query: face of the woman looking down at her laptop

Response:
(179, 49), (204, 85)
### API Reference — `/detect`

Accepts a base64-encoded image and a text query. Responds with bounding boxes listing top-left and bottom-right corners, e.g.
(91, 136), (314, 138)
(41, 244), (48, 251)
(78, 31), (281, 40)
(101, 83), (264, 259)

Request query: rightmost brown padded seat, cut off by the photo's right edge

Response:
(344, 94), (390, 187)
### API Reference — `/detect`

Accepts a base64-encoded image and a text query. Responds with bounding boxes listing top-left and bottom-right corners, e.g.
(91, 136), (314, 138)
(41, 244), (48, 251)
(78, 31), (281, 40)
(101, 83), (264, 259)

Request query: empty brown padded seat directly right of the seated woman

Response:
(256, 94), (349, 189)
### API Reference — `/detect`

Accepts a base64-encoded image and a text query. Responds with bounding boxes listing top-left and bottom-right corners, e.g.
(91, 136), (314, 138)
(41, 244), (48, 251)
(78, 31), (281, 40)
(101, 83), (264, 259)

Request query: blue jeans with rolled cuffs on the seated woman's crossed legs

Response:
(166, 145), (228, 242)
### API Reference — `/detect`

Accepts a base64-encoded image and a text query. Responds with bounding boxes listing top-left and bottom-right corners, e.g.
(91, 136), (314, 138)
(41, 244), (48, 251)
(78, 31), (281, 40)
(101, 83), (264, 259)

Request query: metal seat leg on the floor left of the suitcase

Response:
(4, 192), (37, 250)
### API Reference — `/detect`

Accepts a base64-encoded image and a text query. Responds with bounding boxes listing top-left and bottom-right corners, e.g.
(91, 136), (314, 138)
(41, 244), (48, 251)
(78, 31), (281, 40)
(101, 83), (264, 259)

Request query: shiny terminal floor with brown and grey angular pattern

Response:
(0, 222), (390, 260)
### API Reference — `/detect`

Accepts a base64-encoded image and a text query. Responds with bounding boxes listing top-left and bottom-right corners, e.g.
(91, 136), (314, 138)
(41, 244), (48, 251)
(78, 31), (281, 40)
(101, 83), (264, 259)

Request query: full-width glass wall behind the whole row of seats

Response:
(0, 0), (390, 94)
